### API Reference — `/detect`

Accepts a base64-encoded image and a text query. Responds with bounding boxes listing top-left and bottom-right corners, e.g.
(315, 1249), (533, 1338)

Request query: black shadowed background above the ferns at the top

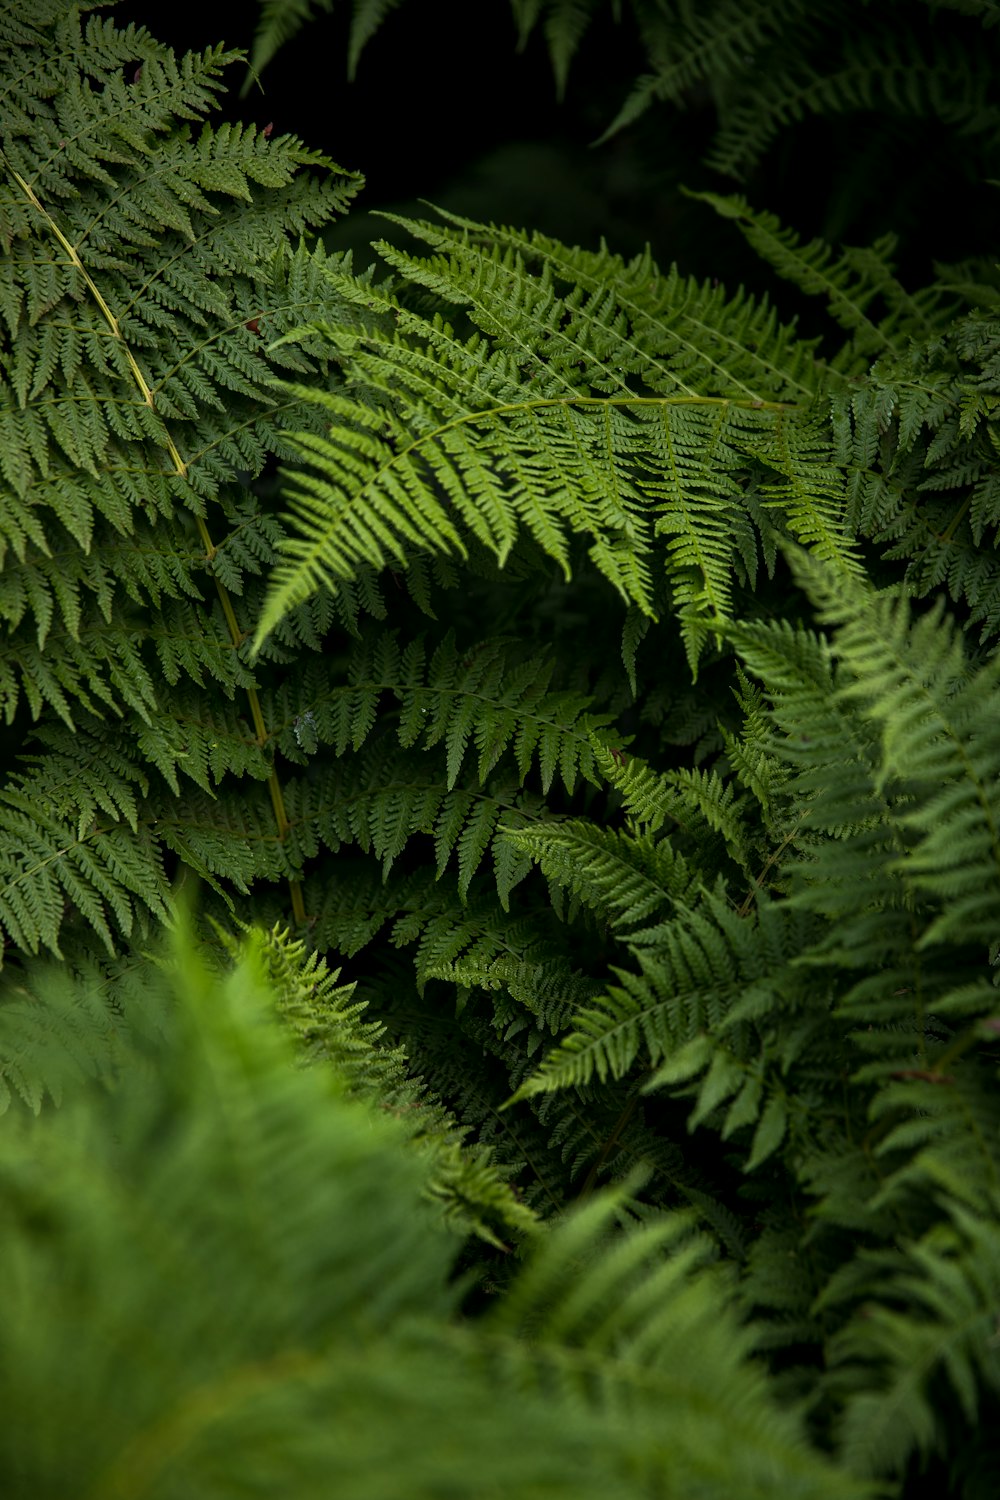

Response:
(115, 0), (996, 321)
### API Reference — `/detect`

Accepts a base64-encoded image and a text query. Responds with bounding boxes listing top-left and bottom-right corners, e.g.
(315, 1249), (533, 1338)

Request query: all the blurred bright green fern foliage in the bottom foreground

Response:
(0, 912), (867, 1500)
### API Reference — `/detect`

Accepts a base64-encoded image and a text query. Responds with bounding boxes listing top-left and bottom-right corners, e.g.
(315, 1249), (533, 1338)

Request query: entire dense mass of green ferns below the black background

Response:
(0, 0), (1000, 1500)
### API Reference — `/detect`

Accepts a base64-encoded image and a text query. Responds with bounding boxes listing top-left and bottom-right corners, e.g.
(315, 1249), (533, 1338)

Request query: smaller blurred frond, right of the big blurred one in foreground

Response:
(486, 1193), (869, 1497)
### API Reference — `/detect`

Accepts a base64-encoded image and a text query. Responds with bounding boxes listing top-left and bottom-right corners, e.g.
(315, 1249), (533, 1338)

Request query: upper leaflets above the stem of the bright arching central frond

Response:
(378, 209), (823, 404)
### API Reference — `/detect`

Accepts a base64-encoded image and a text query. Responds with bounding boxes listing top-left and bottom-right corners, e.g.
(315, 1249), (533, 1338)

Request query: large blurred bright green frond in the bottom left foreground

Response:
(0, 918), (458, 1494)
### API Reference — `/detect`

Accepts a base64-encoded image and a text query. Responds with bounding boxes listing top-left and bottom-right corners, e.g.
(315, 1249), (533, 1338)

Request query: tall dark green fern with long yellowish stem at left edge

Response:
(0, 6), (357, 953)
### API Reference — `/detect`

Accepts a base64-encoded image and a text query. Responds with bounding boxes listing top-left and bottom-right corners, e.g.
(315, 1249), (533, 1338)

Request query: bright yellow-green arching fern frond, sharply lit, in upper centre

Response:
(255, 210), (858, 662)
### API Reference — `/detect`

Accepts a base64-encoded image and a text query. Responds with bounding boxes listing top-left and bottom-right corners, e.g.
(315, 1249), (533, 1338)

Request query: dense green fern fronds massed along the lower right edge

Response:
(511, 557), (1000, 1473)
